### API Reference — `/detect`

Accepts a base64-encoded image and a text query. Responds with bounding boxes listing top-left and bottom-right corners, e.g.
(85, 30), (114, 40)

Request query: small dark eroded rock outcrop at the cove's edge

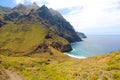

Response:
(51, 42), (72, 52)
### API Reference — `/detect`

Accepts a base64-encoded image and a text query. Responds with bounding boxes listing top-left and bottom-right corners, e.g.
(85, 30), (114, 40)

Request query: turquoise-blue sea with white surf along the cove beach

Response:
(65, 36), (120, 58)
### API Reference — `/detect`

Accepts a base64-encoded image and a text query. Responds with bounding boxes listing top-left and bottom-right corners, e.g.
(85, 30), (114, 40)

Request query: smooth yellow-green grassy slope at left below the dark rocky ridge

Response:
(0, 23), (45, 53)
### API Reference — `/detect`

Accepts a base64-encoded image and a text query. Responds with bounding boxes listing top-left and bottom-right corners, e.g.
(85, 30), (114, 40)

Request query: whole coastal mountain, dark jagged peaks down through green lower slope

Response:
(0, 3), (81, 55)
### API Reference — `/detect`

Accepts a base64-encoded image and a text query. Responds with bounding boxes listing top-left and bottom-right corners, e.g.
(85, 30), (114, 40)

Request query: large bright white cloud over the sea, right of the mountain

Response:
(64, 0), (120, 34)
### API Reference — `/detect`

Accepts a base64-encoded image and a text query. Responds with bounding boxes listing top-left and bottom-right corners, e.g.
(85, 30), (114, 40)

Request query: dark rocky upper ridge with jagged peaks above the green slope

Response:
(4, 3), (81, 43)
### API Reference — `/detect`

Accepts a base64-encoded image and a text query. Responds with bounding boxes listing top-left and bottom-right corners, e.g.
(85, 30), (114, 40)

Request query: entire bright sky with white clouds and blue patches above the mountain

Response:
(0, 0), (120, 35)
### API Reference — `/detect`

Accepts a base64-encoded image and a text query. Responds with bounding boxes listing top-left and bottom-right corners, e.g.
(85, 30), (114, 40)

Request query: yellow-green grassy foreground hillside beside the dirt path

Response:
(0, 51), (120, 80)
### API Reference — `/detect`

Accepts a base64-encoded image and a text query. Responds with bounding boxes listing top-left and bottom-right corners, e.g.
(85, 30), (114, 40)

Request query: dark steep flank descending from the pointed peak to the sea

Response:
(35, 5), (81, 42)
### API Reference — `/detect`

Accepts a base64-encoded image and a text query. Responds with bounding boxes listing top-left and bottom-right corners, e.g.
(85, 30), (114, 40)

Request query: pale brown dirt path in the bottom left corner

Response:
(5, 70), (24, 80)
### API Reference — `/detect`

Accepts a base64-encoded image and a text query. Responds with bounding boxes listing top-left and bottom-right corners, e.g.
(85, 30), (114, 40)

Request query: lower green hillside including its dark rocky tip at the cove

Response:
(0, 21), (72, 55)
